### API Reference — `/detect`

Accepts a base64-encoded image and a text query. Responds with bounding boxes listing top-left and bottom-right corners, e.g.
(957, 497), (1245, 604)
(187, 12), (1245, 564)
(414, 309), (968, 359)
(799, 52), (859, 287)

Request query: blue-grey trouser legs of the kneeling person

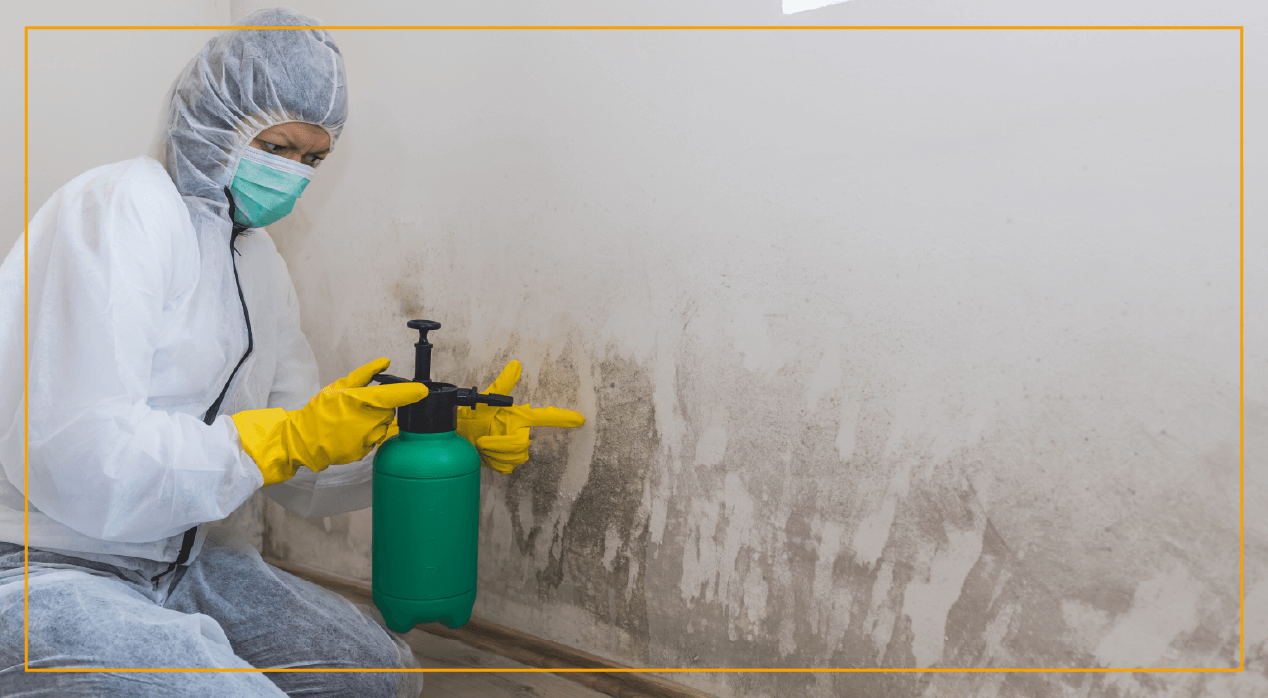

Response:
(0, 529), (422, 698)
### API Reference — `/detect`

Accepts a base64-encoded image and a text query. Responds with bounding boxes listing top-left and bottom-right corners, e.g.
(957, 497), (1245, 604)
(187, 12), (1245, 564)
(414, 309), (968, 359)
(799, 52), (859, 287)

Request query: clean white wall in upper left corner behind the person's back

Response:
(8, 0), (230, 241)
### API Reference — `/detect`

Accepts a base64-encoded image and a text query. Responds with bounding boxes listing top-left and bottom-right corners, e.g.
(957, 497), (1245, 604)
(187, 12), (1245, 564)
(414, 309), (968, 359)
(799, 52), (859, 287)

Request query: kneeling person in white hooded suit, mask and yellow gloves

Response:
(0, 10), (583, 698)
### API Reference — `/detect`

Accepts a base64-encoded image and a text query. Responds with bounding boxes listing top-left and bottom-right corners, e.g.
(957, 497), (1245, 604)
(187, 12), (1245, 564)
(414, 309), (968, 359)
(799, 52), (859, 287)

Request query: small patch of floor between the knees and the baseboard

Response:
(404, 629), (607, 698)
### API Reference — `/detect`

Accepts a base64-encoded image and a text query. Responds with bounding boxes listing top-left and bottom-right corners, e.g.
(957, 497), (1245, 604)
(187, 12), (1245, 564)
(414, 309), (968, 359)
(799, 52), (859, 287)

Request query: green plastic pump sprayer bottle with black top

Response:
(372, 320), (512, 632)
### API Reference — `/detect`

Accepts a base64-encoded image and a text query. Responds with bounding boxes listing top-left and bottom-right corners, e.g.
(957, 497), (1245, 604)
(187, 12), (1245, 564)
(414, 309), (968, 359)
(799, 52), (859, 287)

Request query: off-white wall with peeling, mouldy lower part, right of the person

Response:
(12, 0), (1268, 698)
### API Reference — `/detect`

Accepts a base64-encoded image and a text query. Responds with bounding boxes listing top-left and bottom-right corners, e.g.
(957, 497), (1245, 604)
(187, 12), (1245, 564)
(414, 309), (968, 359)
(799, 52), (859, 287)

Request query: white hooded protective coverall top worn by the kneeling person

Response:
(0, 10), (370, 565)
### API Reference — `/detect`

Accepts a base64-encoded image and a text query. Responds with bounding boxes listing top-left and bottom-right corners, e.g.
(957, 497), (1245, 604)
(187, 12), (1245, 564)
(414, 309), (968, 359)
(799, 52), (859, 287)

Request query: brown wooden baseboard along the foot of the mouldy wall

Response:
(265, 557), (716, 698)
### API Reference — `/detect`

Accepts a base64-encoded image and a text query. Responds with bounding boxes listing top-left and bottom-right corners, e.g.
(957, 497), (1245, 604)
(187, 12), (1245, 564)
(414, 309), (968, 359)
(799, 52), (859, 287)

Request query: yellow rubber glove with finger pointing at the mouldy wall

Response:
(458, 362), (586, 475)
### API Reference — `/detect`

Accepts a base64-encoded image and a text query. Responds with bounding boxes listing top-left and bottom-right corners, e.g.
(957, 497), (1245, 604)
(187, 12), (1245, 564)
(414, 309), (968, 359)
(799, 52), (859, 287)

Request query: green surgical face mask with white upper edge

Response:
(230, 146), (317, 228)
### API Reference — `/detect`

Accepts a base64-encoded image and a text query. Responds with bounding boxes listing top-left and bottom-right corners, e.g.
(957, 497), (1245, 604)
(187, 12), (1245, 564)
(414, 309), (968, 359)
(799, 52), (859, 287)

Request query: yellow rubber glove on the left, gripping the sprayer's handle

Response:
(233, 359), (427, 486)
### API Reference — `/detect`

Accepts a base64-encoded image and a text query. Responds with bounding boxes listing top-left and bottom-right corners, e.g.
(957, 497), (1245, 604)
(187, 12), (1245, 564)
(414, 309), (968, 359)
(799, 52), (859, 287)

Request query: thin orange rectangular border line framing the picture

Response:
(23, 24), (1246, 674)
